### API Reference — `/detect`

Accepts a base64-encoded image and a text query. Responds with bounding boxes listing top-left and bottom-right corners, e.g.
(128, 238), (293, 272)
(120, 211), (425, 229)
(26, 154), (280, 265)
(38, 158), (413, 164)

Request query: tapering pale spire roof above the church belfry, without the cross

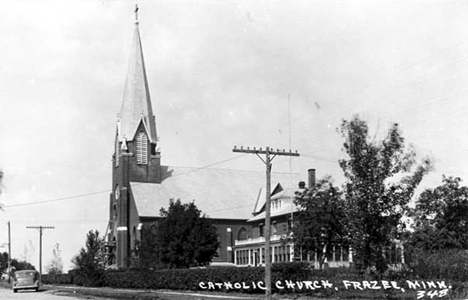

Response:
(119, 23), (157, 142)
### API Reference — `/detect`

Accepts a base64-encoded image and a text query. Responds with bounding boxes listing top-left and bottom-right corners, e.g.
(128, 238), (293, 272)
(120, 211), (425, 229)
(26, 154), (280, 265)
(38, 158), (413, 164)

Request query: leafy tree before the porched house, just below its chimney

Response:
(292, 177), (347, 268)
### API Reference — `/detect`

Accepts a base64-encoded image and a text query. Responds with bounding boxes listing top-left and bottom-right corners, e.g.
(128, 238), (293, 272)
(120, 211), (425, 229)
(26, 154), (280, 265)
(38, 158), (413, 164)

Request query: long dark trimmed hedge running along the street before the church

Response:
(42, 263), (468, 299)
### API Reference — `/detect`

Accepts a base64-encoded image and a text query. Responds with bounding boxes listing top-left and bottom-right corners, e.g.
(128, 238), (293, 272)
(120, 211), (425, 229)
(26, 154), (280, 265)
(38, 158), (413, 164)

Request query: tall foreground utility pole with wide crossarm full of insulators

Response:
(232, 146), (299, 300)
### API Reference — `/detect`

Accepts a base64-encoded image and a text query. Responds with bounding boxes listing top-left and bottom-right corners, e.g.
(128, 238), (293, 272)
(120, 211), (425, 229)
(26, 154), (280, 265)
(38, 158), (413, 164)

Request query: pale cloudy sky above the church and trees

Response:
(0, 0), (468, 270)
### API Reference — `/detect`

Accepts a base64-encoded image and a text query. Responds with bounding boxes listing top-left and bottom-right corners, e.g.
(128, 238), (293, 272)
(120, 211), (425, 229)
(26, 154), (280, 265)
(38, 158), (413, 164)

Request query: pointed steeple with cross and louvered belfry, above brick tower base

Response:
(114, 6), (161, 183)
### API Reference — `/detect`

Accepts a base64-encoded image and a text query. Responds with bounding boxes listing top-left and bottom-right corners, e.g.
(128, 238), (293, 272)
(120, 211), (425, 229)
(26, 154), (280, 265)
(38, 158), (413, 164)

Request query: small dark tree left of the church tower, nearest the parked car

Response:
(72, 230), (105, 285)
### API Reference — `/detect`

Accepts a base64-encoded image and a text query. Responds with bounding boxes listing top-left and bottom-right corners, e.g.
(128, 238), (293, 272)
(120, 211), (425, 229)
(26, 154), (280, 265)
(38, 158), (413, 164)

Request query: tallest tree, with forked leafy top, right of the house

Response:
(339, 116), (431, 273)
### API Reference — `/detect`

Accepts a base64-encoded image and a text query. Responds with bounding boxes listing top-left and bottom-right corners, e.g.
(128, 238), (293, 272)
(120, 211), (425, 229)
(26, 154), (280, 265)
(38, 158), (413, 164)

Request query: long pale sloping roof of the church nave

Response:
(130, 167), (297, 220)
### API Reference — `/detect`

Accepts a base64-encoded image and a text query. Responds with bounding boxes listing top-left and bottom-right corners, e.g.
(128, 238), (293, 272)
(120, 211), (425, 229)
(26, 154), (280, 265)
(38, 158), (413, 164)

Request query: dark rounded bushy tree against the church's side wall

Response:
(138, 199), (219, 268)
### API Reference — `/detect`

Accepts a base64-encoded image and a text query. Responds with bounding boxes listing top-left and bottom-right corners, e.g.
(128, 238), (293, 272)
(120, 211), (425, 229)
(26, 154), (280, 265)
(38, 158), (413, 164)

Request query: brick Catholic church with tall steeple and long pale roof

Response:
(106, 8), (297, 268)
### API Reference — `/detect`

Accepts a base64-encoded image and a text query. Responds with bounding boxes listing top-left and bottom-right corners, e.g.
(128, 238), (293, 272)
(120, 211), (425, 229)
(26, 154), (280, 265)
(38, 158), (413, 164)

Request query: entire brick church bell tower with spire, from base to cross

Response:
(108, 6), (161, 267)
